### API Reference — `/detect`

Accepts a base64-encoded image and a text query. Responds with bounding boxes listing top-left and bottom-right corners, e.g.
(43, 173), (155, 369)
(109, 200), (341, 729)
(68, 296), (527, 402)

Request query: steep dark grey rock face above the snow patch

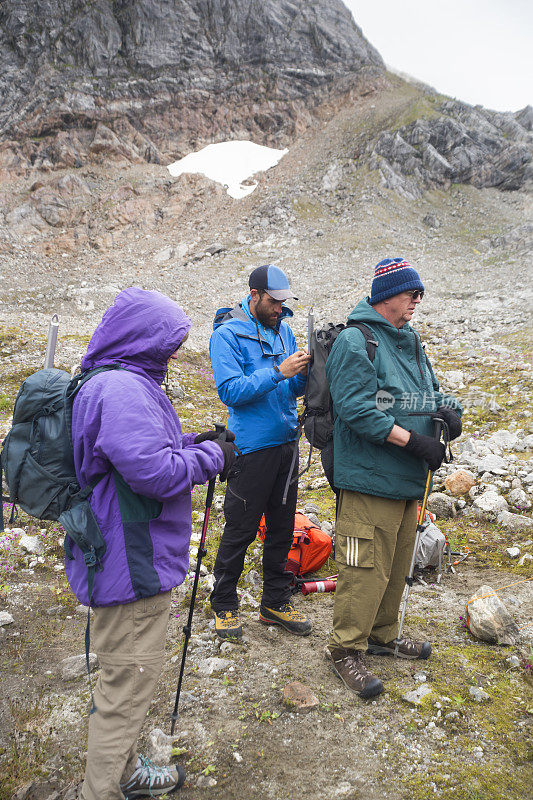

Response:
(0, 0), (384, 170)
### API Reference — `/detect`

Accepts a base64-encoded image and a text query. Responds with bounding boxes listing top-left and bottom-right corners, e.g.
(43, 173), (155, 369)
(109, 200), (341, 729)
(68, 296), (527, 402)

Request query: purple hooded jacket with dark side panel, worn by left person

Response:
(65, 288), (224, 606)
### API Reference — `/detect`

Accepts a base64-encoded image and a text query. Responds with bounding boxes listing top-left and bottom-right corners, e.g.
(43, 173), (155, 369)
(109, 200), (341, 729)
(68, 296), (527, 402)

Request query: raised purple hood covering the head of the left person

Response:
(81, 287), (192, 384)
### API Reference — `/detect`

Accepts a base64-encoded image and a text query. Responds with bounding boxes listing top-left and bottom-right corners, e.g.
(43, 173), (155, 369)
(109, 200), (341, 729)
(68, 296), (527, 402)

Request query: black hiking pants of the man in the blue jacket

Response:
(211, 442), (298, 612)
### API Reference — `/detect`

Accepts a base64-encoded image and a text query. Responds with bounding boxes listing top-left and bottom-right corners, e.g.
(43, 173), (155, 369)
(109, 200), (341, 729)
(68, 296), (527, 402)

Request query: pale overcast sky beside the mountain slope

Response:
(344, 0), (533, 111)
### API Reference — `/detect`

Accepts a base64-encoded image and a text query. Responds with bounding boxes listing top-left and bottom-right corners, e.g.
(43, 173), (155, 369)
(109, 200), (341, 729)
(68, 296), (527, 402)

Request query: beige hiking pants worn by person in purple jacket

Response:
(80, 592), (170, 800)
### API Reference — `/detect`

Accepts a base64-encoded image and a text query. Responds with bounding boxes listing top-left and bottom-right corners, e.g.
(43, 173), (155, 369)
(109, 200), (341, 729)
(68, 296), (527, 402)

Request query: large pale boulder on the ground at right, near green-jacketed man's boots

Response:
(465, 586), (520, 645)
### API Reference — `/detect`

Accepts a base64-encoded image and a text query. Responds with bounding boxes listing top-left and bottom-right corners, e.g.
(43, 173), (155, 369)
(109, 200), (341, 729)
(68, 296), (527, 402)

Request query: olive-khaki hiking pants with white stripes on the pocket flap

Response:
(330, 489), (417, 650)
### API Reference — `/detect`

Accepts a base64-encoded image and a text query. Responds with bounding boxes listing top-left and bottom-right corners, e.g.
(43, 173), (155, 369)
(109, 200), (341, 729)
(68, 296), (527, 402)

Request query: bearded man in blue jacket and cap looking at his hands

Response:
(209, 265), (311, 639)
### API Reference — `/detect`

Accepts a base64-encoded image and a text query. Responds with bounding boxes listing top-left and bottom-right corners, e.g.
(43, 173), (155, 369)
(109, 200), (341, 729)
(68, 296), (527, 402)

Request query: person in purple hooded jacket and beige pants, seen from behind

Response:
(66, 288), (232, 800)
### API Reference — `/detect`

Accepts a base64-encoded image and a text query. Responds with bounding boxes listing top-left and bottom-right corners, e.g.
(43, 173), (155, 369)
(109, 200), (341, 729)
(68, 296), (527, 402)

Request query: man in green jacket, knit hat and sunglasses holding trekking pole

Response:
(326, 258), (462, 698)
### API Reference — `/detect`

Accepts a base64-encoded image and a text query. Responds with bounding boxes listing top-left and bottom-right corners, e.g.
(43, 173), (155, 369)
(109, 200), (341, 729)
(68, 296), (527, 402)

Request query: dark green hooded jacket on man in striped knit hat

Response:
(326, 298), (462, 500)
